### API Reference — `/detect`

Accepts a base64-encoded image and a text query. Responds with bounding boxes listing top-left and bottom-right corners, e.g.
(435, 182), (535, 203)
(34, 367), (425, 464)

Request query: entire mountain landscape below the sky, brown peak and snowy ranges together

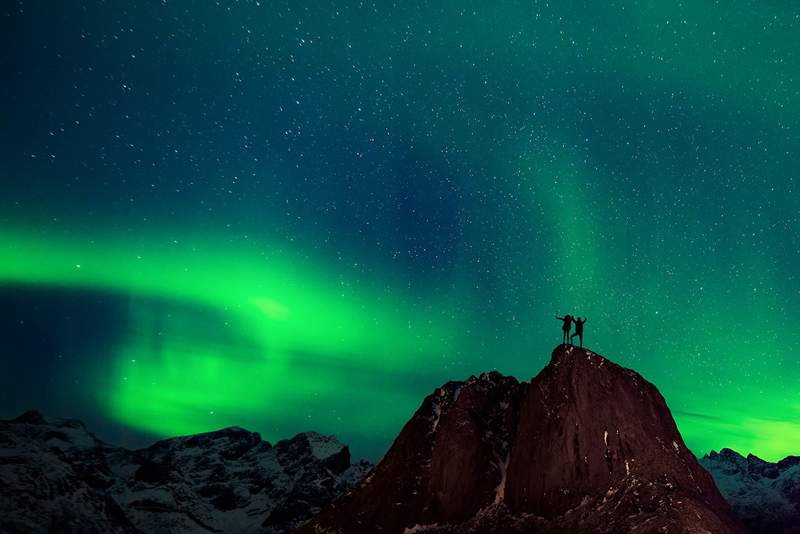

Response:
(0, 345), (800, 534)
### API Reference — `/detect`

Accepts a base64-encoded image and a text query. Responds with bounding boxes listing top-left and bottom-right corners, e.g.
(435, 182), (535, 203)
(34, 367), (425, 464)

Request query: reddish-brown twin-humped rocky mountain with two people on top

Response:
(298, 345), (743, 534)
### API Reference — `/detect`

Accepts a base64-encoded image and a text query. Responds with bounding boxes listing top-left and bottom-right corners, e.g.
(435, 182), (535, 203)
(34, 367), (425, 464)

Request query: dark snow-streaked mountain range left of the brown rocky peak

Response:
(0, 412), (372, 534)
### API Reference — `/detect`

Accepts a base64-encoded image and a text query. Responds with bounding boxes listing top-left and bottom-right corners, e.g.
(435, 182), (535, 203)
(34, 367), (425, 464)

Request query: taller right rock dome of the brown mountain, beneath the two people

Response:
(506, 345), (725, 517)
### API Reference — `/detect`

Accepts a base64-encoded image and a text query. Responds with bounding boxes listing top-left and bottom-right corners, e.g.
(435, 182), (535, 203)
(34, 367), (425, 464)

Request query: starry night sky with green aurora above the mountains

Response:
(0, 0), (800, 460)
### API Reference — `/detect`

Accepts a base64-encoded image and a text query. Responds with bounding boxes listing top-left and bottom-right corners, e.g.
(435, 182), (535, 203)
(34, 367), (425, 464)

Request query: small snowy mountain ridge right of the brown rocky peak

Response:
(700, 449), (800, 534)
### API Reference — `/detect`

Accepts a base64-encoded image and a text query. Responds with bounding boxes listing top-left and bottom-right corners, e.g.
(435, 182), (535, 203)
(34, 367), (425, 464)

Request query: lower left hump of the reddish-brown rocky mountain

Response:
(296, 373), (521, 532)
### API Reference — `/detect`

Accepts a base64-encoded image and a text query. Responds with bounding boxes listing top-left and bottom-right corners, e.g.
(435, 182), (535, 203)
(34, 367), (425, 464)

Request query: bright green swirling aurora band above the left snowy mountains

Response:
(0, 235), (460, 446)
